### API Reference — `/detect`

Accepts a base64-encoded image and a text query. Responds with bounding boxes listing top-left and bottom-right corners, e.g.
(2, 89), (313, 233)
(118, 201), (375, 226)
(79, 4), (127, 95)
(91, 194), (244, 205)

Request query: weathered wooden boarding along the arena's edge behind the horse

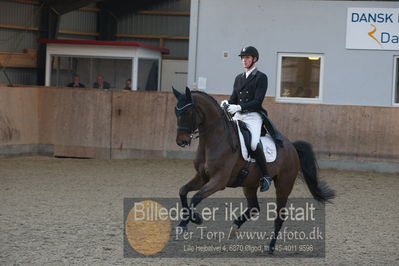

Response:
(0, 87), (399, 162)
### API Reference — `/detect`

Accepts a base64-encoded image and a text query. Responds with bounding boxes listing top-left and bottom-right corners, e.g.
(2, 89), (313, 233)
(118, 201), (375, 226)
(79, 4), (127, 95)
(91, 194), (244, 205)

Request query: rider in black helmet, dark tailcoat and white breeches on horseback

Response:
(221, 46), (272, 192)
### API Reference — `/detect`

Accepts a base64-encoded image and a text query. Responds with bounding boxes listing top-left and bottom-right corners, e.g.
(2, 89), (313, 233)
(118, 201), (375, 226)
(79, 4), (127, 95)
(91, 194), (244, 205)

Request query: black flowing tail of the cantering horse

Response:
(292, 141), (335, 203)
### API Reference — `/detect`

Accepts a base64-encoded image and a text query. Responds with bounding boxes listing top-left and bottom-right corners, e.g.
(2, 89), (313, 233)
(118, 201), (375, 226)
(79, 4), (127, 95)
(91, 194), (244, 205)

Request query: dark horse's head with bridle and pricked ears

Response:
(173, 87), (198, 147)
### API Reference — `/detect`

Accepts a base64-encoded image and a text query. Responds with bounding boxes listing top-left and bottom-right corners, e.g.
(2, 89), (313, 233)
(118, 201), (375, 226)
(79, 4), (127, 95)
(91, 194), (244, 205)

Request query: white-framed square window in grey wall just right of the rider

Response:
(276, 54), (323, 103)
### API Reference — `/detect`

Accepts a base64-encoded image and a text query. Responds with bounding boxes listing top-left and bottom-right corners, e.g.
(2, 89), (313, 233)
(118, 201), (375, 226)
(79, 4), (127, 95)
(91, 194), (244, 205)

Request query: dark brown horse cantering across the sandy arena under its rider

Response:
(173, 87), (335, 253)
